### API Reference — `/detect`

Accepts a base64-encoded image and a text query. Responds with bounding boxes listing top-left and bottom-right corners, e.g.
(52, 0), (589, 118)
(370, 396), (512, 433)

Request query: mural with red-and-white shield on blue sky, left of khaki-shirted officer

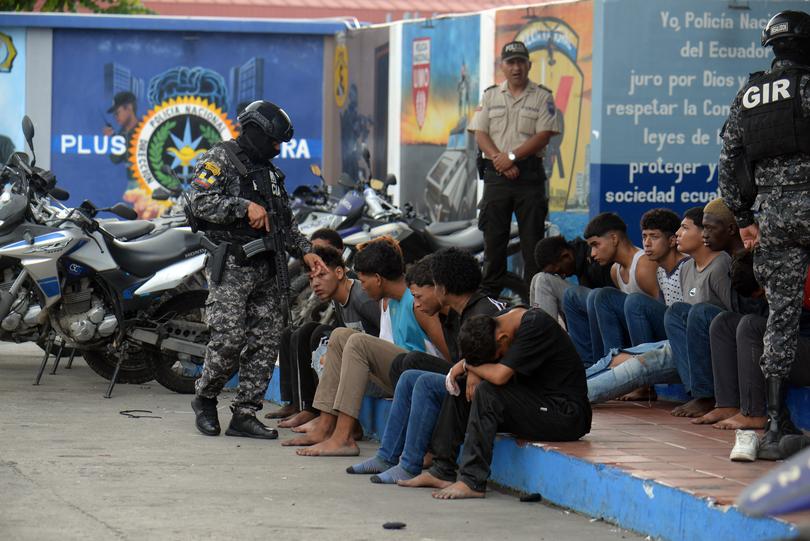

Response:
(400, 15), (481, 221)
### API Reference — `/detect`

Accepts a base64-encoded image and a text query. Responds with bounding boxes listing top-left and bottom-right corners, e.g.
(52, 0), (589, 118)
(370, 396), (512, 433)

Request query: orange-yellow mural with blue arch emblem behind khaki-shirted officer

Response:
(495, 1), (593, 237)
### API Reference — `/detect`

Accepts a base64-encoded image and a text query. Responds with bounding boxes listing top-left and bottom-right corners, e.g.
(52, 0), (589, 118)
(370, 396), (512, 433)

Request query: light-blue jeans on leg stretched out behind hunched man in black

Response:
(586, 340), (678, 404)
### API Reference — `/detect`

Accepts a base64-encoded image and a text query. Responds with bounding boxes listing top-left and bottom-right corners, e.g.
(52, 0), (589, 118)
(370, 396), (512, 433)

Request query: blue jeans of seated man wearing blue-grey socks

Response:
(377, 370), (447, 475)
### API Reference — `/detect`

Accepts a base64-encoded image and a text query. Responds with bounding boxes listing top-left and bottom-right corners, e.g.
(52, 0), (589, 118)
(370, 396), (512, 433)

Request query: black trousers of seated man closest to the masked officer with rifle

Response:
(278, 322), (334, 411)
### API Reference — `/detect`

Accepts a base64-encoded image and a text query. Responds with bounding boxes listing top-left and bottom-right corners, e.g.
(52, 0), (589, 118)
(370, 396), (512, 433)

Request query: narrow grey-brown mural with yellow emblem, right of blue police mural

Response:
(324, 28), (389, 190)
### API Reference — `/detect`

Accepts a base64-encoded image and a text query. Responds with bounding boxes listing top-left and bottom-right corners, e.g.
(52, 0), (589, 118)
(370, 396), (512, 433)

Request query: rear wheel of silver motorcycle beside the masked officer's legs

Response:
(146, 290), (208, 394)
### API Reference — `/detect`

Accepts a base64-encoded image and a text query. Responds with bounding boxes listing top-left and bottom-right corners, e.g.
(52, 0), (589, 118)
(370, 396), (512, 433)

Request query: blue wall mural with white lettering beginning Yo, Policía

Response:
(591, 0), (807, 242)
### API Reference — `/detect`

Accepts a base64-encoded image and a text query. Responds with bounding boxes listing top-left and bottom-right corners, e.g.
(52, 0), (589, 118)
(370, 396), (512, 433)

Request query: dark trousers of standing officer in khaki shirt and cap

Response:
(478, 164), (548, 298)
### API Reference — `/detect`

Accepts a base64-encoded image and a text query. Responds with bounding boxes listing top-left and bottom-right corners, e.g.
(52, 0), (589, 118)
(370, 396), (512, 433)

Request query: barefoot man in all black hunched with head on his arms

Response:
(399, 307), (591, 499)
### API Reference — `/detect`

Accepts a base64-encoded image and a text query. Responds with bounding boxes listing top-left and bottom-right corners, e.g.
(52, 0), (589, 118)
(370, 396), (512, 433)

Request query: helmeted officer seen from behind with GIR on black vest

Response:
(718, 11), (810, 460)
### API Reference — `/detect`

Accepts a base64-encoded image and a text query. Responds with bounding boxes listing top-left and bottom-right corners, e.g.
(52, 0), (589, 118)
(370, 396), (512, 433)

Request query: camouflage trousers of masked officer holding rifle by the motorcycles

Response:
(197, 256), (283, 414)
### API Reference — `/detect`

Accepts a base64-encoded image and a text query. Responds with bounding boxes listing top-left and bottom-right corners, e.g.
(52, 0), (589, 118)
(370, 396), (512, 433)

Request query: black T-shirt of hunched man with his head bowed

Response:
(500, 308), (588, 404)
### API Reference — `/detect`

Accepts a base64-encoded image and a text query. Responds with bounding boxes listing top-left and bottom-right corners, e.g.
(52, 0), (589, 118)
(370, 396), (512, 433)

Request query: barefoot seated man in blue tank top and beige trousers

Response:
(282, 240), (449, 456)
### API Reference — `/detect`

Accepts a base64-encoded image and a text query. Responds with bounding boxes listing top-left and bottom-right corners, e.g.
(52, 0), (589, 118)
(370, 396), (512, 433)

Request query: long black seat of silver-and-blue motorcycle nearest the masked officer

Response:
(109, 229), (202, 278)
